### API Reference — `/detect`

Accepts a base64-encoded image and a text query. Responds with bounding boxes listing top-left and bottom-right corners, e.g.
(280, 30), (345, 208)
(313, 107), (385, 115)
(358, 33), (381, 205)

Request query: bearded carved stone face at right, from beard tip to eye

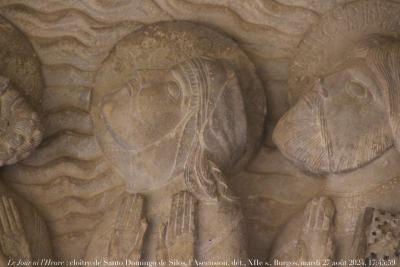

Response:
(274, 63), (392, 173)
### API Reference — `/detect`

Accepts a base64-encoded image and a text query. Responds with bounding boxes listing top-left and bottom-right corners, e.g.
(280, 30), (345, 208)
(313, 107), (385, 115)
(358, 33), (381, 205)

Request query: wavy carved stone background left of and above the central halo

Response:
(0, 0), (340, 258)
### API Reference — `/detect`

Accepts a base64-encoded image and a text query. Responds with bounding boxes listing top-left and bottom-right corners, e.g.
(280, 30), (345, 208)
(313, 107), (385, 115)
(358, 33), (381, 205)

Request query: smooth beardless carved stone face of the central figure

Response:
(102, 71), (188, 151)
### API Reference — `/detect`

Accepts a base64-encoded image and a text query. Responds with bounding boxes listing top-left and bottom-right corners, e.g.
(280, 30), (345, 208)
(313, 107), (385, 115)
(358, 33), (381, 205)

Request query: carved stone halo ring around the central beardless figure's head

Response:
(91, 21), (266, 175)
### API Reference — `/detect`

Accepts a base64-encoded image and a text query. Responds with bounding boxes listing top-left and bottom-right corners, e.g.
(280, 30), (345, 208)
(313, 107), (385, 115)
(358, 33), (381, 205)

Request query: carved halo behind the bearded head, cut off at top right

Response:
(289, 0), (400, 104)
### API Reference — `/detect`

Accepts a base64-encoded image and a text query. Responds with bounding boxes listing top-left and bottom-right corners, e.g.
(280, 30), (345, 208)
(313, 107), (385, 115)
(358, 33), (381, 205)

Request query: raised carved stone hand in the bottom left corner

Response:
(0, 196), (31, 260)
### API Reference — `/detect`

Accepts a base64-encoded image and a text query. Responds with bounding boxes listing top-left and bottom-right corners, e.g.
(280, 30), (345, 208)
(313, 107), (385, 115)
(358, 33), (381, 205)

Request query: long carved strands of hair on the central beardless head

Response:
(173, 58), (247, 200)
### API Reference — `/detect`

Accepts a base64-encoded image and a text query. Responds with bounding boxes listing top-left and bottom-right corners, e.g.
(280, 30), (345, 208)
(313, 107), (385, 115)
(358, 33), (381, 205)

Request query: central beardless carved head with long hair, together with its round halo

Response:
(91, 21), (266, 200)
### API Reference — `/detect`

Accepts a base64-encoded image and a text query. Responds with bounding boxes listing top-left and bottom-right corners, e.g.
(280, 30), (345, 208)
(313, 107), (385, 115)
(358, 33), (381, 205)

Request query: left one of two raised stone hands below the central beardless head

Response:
(108, 194), (147, 261)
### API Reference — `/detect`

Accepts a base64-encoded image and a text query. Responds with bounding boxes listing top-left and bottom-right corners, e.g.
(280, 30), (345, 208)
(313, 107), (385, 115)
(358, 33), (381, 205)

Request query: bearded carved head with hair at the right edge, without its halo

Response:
(274, 35), (400, 173)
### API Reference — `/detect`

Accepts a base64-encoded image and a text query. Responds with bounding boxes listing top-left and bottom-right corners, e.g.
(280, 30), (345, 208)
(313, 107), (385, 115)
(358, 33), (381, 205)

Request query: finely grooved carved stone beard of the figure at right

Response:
(273, 90), (392, 174)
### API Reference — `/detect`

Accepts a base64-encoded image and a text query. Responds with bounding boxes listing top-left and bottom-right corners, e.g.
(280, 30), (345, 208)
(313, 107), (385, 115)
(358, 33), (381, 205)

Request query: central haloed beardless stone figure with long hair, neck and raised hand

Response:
(88, 22), (265, 265)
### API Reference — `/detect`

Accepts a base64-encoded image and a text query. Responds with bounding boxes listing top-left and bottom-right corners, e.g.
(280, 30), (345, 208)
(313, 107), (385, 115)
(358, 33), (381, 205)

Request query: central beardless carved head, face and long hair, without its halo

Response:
(101, 58), (247, 201)
